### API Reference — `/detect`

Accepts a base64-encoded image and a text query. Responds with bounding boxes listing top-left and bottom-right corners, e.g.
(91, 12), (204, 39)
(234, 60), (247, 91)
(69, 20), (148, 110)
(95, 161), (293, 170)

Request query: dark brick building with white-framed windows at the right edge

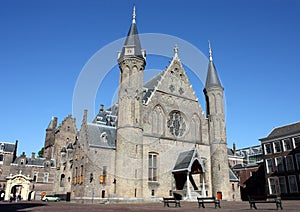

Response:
(259, 122), (300, 199)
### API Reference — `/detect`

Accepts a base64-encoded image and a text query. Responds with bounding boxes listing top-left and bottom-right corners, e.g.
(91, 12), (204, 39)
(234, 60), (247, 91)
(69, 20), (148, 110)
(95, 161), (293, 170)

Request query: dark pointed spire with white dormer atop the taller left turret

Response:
(118, 6), (145, 60)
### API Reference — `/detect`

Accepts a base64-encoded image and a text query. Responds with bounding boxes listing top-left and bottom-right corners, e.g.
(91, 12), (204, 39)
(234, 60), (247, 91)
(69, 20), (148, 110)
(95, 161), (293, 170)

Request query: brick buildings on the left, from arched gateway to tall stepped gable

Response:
(0, 115), (77, 200)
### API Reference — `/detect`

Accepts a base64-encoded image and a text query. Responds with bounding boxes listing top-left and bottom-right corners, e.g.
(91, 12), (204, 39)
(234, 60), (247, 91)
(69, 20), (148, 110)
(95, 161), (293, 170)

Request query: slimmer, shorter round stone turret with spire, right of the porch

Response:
(204, 42), (230, 199)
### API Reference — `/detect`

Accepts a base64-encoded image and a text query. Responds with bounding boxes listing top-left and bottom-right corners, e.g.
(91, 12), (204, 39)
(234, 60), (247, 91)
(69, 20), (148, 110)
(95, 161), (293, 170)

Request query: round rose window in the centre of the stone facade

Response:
(167, 111), (186, 137)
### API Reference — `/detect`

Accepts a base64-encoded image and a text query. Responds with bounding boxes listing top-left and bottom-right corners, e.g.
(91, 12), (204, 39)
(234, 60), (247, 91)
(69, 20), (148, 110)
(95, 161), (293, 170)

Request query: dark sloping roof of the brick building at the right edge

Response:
(259, 122), (300, 141)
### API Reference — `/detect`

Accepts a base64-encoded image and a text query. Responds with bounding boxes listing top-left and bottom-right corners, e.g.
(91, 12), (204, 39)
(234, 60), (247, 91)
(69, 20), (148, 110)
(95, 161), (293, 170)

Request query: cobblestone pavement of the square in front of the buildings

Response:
(0, 201), (300, 212)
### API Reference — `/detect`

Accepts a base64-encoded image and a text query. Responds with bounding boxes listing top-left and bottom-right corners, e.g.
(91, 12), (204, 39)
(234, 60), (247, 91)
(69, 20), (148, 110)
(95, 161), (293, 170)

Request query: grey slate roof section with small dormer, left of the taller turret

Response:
(87, 123), (116, 149)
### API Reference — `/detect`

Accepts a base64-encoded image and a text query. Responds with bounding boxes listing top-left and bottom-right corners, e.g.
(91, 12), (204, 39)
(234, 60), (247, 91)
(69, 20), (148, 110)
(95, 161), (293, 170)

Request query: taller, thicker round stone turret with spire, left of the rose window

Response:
(115, 7), (146, 198)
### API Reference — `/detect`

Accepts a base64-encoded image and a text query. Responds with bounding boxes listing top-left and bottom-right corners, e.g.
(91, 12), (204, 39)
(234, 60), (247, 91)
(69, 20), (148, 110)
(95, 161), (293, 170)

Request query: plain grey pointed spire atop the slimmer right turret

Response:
(205, 41), (222, 89)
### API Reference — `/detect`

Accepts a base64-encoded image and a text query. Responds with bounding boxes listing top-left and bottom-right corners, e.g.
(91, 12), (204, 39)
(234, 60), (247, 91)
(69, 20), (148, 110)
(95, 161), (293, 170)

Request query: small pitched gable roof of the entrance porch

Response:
(172, 148), (205, 173)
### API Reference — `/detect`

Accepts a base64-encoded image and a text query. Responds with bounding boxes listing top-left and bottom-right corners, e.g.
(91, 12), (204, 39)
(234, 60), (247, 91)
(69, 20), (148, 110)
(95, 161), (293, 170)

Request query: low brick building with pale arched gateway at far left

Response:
(0, 138), (55, 200)
